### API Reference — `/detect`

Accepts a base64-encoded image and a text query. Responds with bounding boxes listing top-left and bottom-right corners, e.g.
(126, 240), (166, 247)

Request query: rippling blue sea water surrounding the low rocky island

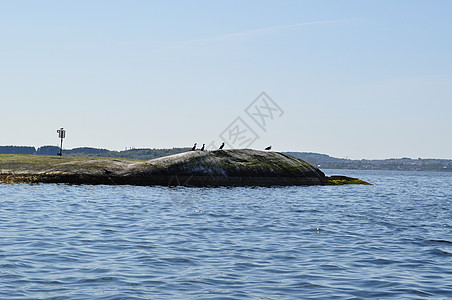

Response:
(0, 170), (452, 299)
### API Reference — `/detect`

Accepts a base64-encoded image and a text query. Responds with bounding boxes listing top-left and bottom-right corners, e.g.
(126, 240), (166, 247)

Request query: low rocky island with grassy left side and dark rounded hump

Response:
(0, 149), (368, 186)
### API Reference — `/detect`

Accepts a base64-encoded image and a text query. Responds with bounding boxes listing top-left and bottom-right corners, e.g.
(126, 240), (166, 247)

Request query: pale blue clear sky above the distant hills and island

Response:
(0, 0), (452, 159)
